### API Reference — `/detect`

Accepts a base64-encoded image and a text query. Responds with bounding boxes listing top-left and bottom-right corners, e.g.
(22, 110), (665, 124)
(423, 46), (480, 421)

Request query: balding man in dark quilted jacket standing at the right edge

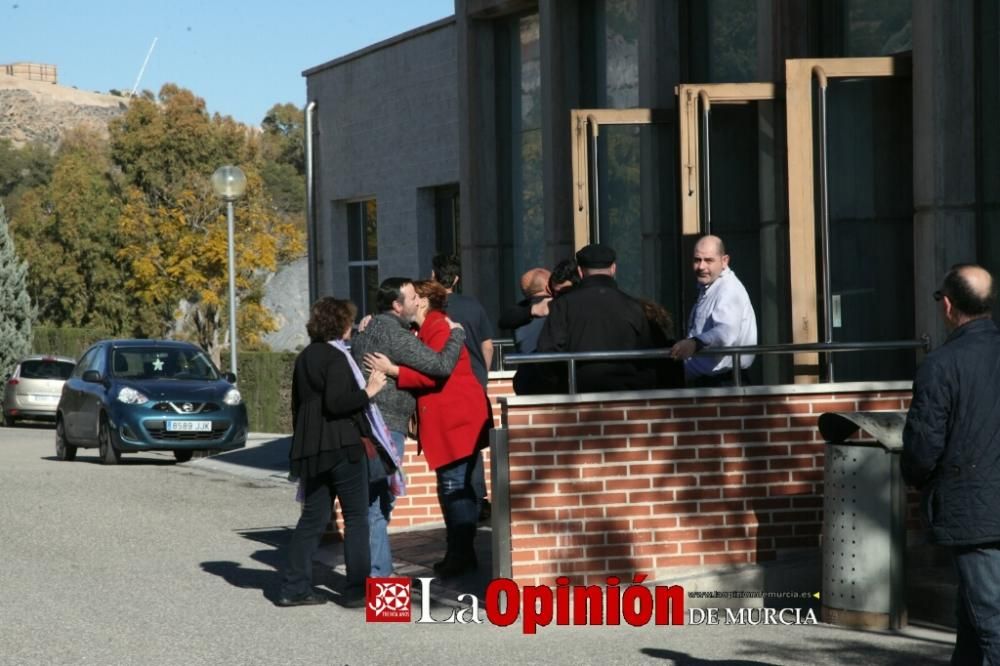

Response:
(902, 264), (1000, 664)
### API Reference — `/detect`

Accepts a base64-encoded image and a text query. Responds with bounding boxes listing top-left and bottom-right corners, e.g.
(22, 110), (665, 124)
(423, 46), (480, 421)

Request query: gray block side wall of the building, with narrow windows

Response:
(305, 19), (458, 298)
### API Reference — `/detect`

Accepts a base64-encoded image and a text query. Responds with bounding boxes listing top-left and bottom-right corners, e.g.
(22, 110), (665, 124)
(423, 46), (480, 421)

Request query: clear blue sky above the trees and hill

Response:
(0, 0), (455, 125)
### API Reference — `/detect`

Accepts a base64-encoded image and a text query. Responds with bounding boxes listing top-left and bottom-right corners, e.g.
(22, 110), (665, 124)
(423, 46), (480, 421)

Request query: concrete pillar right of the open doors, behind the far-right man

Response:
(913, 0), (976, 346)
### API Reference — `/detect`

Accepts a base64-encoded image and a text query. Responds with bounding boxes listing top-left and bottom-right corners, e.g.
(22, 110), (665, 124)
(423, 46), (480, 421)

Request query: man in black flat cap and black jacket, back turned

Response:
(537, 243), (654, 392)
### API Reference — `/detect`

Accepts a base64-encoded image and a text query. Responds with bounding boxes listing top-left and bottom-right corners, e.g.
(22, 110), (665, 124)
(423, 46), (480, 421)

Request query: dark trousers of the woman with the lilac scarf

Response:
(281, 452), (371, 597)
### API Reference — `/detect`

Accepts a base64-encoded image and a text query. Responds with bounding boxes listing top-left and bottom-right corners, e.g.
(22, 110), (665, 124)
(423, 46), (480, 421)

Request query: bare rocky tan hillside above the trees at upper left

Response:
(0, 74), (128, 148)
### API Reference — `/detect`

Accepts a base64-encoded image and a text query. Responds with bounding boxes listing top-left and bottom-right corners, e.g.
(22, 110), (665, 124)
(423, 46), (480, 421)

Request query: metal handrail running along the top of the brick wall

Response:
(503, 334), (931, 393)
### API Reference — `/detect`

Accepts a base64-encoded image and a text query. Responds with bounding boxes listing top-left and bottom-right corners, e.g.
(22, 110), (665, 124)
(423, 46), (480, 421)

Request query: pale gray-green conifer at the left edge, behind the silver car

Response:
(0, 203), (34, 377)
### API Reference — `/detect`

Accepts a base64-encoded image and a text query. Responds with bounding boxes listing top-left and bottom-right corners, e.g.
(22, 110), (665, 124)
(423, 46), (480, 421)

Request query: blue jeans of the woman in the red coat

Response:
(437, 451), (486, 556)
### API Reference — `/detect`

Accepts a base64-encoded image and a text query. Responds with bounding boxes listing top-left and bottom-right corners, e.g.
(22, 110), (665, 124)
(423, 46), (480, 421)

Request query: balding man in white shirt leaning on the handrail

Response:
(670, 236), (757, 387)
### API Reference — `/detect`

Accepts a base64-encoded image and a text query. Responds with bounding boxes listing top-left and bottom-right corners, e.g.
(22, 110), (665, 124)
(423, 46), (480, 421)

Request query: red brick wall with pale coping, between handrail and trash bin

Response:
(504, 387), (910, 584)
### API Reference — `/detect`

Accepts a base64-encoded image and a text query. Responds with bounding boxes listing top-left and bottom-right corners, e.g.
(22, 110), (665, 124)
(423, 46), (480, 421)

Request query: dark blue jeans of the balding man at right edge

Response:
(951, 543), (1000, 666)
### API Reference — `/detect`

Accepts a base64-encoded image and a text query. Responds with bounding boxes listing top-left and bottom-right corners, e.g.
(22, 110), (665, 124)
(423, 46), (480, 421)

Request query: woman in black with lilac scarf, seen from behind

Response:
(275, 297), (385, 607)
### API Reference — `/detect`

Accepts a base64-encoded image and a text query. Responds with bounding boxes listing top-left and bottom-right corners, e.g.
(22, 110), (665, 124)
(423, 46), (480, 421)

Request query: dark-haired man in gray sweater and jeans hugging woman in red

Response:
(351, 278), (465, 577)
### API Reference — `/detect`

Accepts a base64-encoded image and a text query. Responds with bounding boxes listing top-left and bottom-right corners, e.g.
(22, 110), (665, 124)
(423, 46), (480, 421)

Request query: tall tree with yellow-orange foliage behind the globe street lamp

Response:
(110, 84), (304, 361)
